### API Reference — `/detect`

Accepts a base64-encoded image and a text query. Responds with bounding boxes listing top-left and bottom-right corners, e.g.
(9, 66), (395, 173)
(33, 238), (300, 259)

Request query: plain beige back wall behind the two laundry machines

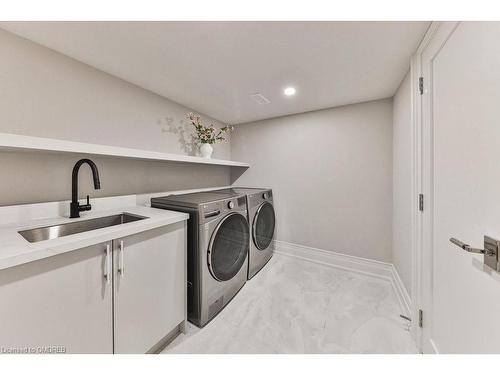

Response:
(231, 99), (392, 262)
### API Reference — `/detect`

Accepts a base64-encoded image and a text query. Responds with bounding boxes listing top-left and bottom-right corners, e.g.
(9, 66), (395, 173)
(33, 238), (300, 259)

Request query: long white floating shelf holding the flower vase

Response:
(0, 133), (250, 168)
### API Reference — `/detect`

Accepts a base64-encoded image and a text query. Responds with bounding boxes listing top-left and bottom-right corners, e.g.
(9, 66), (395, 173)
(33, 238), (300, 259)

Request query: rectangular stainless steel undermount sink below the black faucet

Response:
(18, 212), (147, 242)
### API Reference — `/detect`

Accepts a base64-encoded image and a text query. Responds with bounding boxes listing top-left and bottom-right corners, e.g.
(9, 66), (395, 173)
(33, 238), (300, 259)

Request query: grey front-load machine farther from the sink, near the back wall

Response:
(213, 187), (276, 280)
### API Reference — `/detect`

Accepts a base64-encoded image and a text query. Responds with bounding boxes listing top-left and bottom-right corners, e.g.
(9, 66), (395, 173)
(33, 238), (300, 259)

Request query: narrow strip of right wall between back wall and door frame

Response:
(392, 73), (415, 295)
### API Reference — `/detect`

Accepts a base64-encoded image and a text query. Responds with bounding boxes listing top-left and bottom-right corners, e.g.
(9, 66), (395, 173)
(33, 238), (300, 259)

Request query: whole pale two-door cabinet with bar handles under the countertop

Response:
(0, 222), (186, 353)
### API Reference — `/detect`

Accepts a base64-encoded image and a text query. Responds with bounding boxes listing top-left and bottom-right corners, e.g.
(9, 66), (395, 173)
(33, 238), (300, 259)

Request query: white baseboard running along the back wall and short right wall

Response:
(273, 240), (413, 319)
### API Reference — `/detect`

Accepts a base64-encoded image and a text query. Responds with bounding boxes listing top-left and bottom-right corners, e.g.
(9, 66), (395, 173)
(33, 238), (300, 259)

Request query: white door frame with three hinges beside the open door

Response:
(411, 22), (460, 354)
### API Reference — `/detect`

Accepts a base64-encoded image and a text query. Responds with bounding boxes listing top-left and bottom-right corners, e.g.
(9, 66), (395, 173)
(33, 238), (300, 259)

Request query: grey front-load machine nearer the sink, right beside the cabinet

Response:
(151, 192), (250, 327)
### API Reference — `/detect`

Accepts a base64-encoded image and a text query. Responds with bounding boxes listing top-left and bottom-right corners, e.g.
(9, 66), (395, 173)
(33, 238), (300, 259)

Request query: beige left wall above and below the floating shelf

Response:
(0, 30), (230, 205)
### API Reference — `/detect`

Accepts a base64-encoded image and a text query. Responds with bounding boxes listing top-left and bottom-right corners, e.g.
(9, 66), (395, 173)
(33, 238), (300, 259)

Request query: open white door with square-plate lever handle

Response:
(422, 22), (500, 353)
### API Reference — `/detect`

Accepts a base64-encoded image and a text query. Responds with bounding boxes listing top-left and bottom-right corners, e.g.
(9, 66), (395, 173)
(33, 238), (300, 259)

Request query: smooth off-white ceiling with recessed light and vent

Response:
(0, 21), (429, 124)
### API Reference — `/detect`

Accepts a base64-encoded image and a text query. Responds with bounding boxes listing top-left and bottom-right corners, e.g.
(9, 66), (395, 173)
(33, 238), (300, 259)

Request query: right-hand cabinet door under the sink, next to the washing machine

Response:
(113, 222), (186, 353)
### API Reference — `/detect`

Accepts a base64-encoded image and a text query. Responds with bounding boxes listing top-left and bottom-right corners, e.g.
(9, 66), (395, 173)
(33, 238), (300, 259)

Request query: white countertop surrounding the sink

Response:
(0, 206), (189, 270)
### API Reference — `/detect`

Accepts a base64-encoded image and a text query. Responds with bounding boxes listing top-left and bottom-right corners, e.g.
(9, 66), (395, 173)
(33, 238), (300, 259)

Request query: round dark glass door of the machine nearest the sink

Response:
(208, 213), (250, 281)
